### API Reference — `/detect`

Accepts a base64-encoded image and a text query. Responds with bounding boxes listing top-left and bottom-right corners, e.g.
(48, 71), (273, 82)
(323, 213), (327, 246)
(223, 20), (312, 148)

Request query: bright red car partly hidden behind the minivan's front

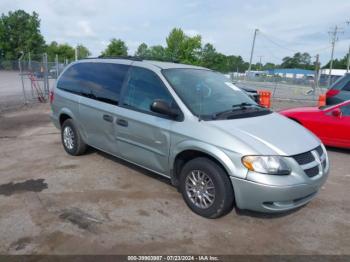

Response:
(279, 100), (350, 148)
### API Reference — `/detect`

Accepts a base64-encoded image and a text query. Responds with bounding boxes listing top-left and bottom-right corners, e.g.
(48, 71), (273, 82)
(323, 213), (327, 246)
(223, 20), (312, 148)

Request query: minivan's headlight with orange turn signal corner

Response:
(242, 156), (291, 175)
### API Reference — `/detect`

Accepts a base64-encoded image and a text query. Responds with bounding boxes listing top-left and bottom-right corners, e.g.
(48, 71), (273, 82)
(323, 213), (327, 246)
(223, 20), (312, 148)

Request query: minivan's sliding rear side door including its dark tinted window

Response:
(79, 61), (129, 155)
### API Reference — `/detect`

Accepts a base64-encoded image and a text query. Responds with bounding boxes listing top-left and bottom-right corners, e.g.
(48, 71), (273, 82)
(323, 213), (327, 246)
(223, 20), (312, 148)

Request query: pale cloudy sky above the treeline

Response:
(0, 0), (350, 63)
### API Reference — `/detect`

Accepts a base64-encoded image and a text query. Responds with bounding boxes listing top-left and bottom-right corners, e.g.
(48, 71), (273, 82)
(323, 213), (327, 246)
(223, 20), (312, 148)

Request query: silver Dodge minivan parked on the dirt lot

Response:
(50, 58), (329, 218)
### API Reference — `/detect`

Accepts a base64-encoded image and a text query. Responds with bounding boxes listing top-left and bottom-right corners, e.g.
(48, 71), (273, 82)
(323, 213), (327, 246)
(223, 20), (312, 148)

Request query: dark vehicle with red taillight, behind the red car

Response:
(326, 73), (350, 105)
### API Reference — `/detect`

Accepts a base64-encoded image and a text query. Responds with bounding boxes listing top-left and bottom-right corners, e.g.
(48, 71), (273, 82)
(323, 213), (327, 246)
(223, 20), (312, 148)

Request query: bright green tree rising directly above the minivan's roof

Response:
(166, 28), (202, 64)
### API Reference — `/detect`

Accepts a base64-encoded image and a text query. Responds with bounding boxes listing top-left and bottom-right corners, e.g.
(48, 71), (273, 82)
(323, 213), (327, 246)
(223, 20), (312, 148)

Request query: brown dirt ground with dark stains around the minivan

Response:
(0, 105), (350, 254)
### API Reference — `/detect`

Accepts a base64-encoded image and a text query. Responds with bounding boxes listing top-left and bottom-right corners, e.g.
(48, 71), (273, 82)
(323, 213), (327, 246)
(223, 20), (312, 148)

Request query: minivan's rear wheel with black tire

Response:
(61, 119), (87, 156)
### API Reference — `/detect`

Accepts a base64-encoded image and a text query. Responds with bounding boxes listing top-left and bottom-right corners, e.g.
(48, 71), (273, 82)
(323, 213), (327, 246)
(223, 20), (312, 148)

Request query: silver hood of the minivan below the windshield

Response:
(207, 113), (320, 156)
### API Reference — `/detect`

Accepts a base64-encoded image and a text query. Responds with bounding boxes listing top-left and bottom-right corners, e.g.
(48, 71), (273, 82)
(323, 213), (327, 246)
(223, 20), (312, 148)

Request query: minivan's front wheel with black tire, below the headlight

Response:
(180, 157), (234, 218)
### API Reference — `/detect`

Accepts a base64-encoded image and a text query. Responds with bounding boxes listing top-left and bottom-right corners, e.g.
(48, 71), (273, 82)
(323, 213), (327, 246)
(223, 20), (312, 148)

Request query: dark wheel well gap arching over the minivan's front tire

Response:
(172, 150), (227, 186)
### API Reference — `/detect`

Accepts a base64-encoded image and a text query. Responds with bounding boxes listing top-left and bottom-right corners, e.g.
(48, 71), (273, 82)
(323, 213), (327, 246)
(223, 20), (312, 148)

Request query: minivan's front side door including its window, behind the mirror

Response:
(115, 66), (176, 174)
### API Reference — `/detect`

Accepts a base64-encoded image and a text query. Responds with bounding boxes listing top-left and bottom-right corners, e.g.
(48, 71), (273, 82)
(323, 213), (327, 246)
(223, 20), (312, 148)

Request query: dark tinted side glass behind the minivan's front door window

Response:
(58, 63), (129, 105)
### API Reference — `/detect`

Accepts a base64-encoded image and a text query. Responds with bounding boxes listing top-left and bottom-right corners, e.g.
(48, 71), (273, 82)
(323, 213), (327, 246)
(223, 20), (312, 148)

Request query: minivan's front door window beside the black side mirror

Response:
(123, 67), (173, 112)
